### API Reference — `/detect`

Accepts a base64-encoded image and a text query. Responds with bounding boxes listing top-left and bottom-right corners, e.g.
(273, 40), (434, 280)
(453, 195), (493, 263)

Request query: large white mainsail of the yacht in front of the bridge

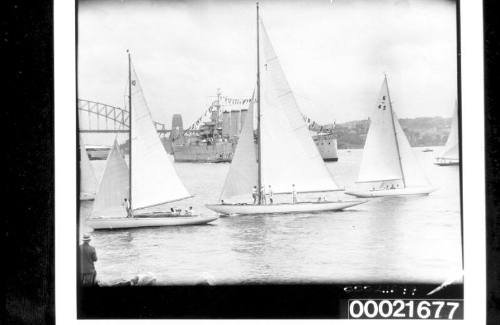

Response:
(130, 67), (191, 209)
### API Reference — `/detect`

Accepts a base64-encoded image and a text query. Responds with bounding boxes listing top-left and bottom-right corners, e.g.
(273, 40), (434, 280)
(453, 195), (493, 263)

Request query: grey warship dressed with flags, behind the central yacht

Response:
(163, 90), (338, 163)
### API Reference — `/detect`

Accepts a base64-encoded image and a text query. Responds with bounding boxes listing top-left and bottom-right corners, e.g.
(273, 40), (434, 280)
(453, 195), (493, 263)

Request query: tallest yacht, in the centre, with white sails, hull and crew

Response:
(206, 4), (366, 215)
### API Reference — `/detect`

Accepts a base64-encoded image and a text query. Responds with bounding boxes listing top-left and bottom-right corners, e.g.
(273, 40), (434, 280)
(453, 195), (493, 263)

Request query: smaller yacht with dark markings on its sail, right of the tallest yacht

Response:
(346, 77), (435, 197)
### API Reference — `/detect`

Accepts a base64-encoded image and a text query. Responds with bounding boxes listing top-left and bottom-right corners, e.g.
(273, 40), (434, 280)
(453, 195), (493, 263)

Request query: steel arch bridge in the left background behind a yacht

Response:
(78, 99), (170, 137)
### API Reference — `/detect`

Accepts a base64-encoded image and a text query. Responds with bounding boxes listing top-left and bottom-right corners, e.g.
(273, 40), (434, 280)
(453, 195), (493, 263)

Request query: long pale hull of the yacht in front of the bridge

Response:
(87, 216), (218, 230)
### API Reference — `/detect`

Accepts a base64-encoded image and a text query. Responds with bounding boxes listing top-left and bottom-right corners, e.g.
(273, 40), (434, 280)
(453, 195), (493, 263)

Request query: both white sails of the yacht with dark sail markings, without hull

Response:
(357, 78), (429, 187)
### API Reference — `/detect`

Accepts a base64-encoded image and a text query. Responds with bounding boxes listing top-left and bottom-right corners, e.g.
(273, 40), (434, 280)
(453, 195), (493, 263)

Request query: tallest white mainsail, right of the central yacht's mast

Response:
(259, 19), (339, 193)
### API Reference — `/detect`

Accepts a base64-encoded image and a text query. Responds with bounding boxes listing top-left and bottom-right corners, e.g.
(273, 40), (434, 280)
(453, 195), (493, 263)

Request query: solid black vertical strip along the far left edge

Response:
(5, 0), (55, 324)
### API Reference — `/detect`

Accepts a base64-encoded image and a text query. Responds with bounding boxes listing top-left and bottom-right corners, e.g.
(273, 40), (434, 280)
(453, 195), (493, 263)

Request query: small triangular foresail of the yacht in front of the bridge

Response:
(92, 139), (129, 217)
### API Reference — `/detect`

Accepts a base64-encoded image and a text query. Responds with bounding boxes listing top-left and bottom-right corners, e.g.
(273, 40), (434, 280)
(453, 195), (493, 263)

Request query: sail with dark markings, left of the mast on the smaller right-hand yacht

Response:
(358, 78), (403, 182)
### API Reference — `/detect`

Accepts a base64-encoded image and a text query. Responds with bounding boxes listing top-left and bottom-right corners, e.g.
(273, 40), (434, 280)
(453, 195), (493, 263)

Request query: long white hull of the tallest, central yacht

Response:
(206, 200), (366, 215)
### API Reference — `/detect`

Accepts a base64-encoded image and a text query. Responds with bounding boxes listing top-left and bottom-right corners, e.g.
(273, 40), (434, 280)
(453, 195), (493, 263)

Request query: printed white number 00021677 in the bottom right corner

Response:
(348, 299), (463, 319)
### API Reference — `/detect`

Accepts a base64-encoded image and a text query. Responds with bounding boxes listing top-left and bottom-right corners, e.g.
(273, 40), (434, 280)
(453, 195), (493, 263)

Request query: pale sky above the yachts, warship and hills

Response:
(78, 0), (457, 133)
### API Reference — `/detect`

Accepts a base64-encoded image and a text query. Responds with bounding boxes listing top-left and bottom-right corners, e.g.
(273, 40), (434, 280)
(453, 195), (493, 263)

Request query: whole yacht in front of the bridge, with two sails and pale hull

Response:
(87, 53), (218, 230)
